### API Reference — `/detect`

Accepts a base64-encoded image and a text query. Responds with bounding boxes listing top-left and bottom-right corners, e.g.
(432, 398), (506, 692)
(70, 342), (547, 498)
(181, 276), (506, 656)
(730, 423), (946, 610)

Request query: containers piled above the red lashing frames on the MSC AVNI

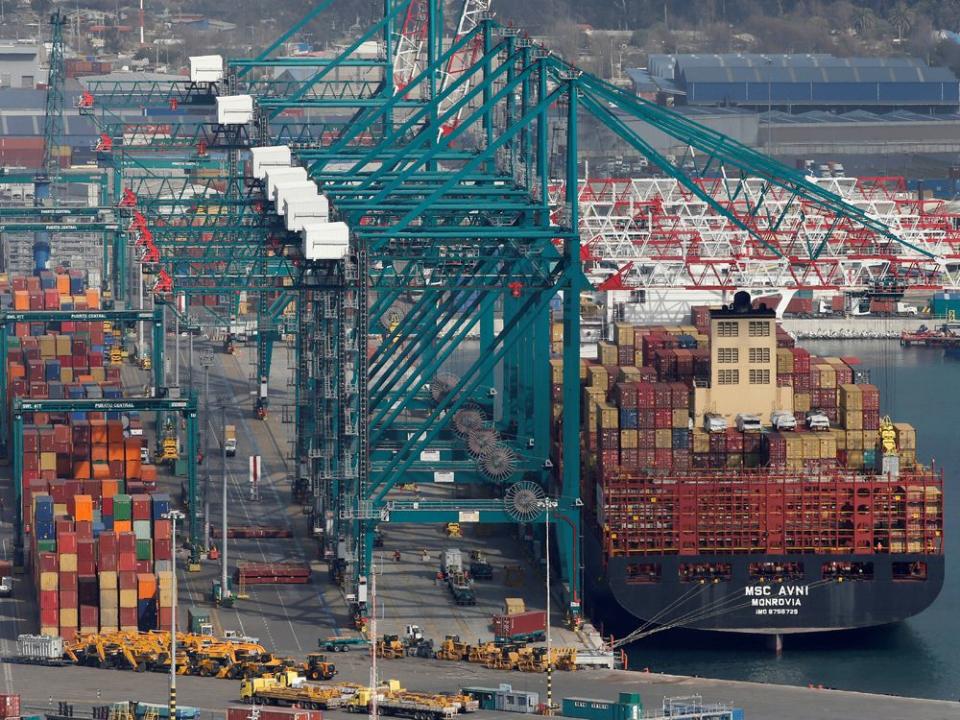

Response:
(551, 307), (916, 490)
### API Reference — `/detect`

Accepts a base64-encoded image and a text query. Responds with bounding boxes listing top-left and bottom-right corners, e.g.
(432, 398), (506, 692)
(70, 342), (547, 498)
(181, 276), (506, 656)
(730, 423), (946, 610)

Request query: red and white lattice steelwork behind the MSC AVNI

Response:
(553, 177), (960, 290)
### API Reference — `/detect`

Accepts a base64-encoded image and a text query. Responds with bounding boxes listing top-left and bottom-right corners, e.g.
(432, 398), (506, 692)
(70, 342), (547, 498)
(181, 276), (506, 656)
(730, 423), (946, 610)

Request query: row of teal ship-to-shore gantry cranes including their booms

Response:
(71, 0), (941, 632)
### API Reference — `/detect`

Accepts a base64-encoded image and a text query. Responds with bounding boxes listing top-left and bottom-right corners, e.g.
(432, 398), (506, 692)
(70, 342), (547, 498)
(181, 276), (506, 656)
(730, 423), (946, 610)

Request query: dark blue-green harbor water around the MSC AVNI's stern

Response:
(618, 340), (960, 700)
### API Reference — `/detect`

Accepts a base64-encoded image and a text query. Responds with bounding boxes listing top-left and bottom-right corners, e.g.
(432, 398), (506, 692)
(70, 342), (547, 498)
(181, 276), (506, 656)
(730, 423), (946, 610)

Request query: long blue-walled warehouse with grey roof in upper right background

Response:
(629, 54), (960, 114)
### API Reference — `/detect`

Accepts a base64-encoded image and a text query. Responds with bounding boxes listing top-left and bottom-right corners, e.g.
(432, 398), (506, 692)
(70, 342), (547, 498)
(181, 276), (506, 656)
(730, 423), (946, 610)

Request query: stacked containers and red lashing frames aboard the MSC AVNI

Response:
(552, 308), (943, 554)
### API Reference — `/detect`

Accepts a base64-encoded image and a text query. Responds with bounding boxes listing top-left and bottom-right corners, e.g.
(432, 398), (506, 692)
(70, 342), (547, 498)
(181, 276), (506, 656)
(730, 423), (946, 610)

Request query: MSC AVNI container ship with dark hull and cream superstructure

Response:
(552, 293), (944, 635)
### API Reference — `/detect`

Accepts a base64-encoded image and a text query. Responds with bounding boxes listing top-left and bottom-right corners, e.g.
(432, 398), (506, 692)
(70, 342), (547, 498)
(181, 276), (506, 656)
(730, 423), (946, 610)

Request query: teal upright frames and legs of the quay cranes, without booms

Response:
(262, 8), (583, 615)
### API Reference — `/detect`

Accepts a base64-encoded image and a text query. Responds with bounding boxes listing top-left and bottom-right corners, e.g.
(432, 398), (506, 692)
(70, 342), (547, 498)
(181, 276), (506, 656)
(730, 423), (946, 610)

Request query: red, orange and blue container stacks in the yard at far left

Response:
(0, 269), (174, 640)
